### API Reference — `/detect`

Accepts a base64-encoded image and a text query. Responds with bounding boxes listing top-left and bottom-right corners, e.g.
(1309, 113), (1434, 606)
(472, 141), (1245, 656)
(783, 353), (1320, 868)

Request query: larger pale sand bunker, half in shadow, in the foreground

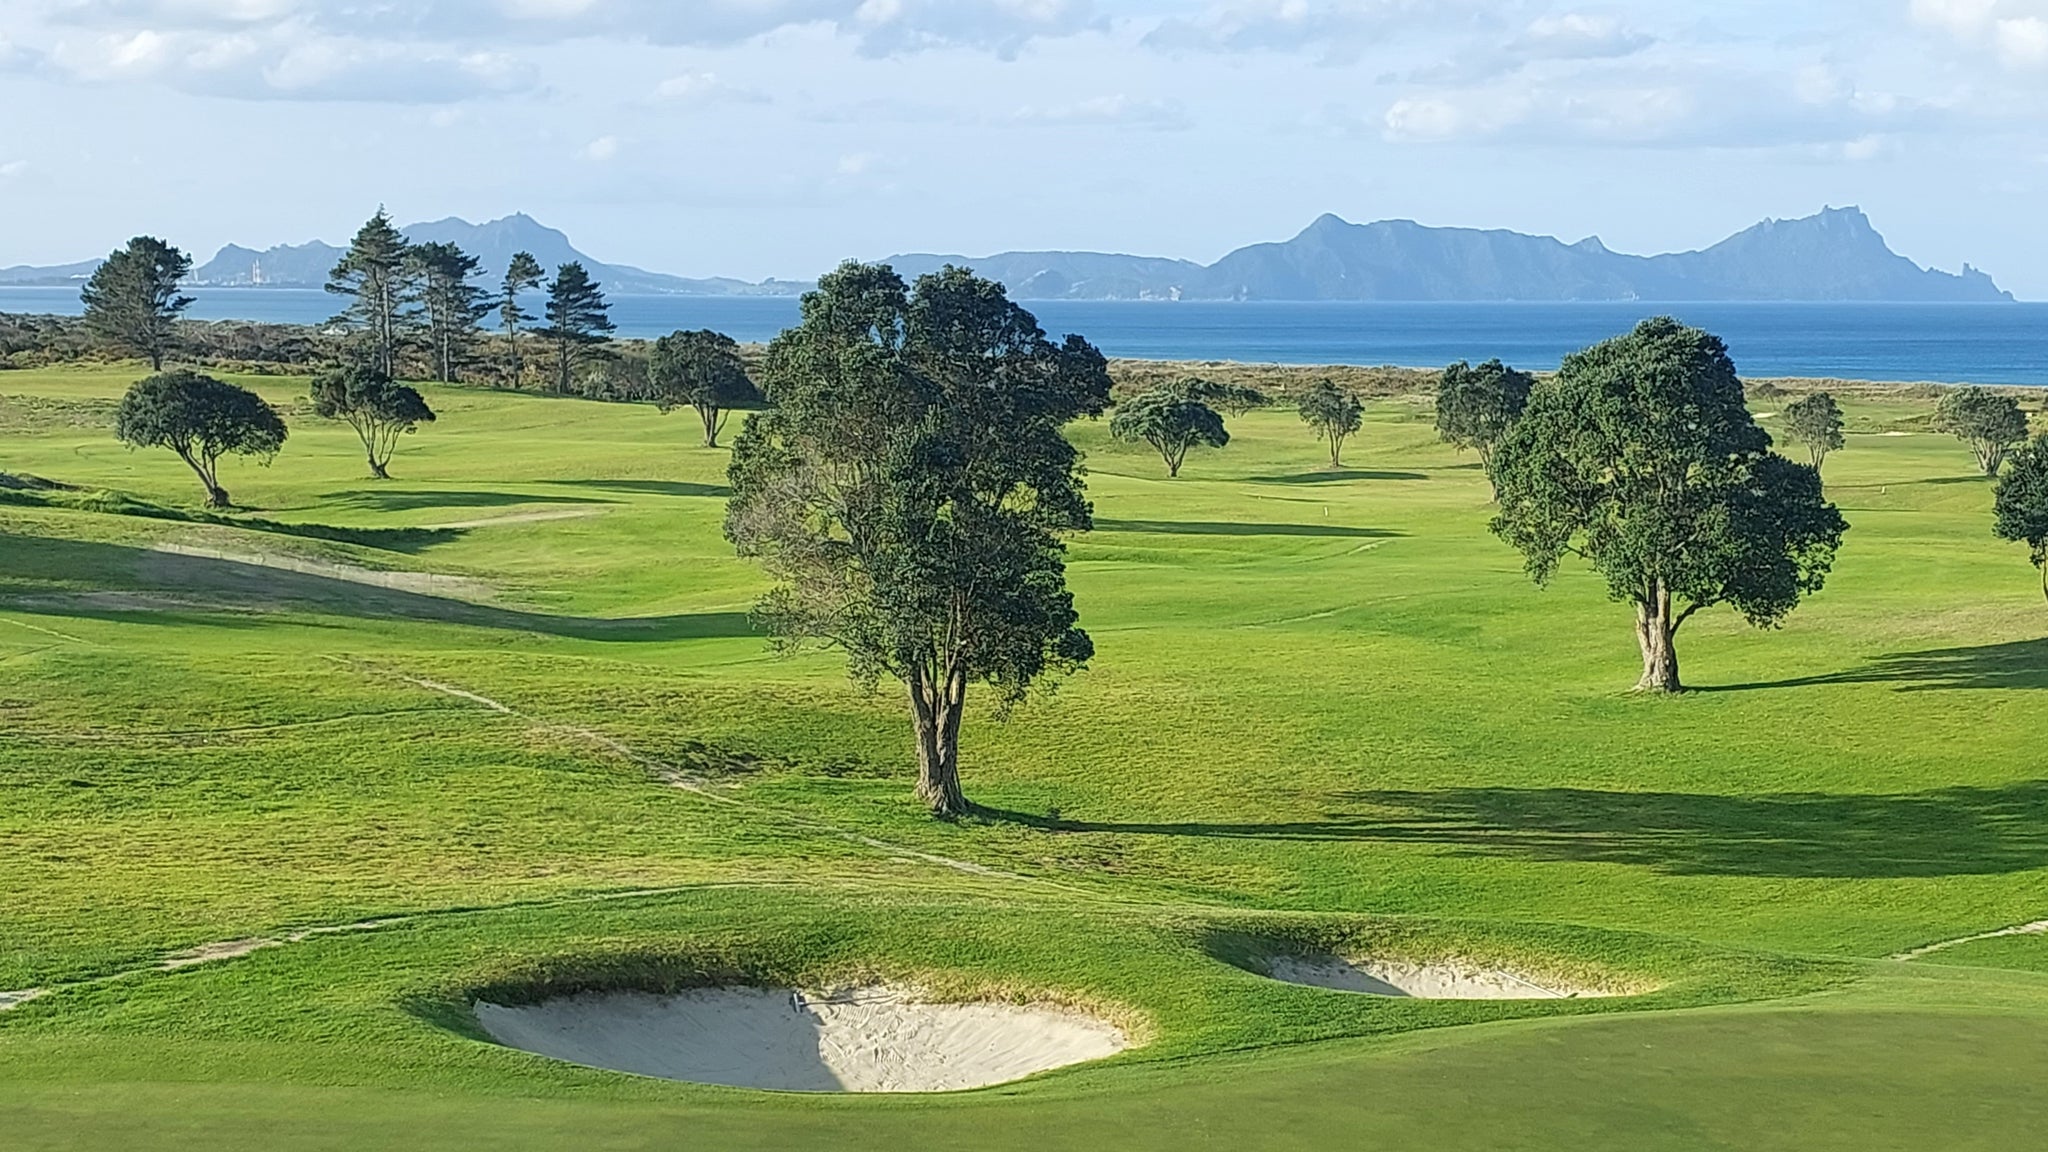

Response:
(475, 988), (1128, 1093)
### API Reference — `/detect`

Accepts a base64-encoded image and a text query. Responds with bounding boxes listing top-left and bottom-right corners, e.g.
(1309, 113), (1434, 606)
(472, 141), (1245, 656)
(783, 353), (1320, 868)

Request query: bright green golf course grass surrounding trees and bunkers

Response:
(0, 360), (2048, 1150)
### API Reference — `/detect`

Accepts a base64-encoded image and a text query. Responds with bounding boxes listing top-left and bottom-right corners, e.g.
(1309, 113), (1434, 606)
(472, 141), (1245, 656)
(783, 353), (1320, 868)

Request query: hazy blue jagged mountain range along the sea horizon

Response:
(0, 207), (2013, 301)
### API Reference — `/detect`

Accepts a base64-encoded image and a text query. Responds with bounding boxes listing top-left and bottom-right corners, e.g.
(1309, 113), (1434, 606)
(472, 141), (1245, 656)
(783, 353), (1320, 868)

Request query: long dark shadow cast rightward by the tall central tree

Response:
(987, 781), (2048, 879)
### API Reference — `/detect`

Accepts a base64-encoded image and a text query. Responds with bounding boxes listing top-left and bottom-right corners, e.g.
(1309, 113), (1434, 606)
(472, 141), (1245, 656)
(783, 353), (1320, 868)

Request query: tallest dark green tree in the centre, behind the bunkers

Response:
(725, 262), (1110, 816)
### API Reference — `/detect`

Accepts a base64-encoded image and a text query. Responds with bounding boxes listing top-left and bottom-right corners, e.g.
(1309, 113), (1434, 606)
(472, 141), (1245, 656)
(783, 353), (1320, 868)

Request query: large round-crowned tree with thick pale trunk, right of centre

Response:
(1491, 318), (1847, 693)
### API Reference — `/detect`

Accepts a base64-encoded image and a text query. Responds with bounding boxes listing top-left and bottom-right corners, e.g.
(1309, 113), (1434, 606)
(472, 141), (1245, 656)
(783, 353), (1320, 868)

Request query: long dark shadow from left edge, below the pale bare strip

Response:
(0, 535), (756, 644)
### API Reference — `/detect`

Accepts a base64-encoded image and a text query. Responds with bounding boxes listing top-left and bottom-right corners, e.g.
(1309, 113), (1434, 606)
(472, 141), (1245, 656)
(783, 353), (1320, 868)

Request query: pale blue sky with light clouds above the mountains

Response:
(0, 0), (2048, 299)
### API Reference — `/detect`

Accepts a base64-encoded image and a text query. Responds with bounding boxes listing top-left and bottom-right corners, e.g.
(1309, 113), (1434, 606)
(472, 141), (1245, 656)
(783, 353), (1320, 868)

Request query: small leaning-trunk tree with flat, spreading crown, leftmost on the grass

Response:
(115, 369), (285, 508)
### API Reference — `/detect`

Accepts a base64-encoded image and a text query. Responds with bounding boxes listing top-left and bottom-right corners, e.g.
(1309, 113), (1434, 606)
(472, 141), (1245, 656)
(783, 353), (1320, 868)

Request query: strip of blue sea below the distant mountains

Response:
(0, 287), (2048, 385)
